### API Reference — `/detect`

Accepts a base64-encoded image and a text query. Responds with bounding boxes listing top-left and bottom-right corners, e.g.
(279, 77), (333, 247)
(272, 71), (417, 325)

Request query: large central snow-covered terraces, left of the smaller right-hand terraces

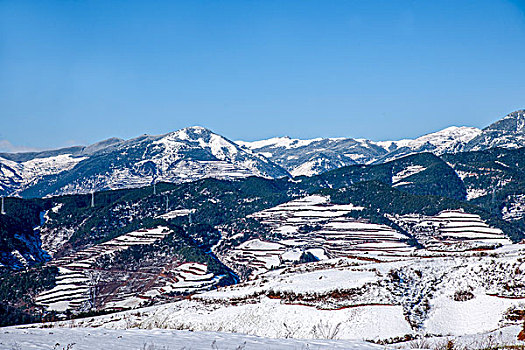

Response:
(224, 195), (415, 274)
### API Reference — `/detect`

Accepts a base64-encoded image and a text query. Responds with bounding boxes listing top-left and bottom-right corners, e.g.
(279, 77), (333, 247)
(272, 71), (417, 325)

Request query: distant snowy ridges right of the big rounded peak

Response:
(237, 110), (525, 176)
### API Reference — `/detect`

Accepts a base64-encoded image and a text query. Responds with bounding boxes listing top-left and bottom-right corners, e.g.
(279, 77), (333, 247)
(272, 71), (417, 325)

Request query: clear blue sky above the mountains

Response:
(0, 0), (525, 149)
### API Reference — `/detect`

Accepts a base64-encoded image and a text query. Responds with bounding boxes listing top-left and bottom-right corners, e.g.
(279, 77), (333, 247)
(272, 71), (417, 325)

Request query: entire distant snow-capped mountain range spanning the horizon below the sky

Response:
(0, 110), (525, 197)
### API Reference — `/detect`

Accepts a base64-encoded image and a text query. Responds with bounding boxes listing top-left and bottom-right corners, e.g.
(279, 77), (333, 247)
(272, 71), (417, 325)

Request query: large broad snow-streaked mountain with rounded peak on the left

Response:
(0, 127), (288, 197)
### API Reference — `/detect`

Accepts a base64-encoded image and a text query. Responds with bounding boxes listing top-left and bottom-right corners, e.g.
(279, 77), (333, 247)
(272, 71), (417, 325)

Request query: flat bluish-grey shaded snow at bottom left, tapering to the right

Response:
(0, 327), (384, 350)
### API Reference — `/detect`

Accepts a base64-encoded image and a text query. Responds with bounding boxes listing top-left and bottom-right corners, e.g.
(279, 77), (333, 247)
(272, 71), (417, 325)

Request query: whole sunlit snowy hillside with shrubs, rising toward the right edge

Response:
(28, 244), (525, 348)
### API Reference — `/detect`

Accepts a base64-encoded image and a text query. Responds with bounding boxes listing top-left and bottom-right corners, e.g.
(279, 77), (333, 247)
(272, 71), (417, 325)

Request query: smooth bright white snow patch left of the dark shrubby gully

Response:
(41, 298), (412, 340)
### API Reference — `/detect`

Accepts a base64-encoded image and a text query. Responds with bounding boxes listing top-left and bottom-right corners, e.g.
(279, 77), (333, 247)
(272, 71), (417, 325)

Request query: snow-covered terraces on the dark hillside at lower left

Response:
(36, 226), (220, 311)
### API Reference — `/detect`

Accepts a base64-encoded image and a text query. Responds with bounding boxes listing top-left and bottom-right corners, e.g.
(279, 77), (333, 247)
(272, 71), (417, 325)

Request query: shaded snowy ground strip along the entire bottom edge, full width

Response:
(0, 326), (520, 350)
